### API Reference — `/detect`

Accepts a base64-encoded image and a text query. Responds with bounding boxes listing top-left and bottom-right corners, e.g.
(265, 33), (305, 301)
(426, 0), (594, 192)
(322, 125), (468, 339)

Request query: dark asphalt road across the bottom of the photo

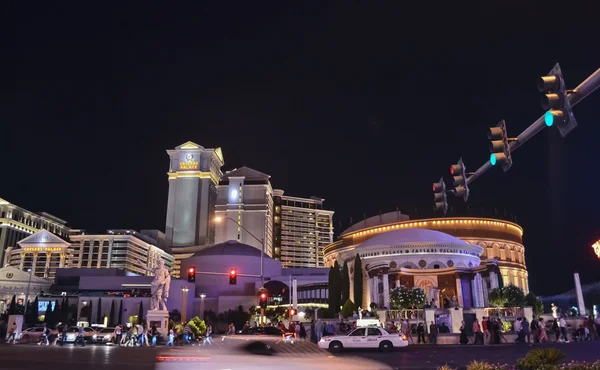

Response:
(0, 342), (600, 370)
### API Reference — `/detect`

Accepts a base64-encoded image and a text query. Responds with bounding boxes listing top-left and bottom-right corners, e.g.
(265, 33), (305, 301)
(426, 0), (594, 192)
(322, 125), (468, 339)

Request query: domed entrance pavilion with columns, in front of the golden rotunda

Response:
(324, 220), (501, 308)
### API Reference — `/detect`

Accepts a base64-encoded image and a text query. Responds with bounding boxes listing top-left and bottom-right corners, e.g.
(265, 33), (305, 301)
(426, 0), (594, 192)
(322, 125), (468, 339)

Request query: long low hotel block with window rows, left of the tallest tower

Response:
(66, 230), (175, 275)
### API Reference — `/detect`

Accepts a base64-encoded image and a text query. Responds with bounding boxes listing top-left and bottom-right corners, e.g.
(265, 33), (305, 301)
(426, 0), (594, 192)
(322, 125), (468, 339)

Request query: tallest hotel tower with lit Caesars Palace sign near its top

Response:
(165, 141), (225, 251)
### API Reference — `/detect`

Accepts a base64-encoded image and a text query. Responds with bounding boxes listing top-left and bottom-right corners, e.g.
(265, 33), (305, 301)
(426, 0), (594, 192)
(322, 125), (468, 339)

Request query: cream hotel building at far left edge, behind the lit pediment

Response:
(0, 198), (70, 261)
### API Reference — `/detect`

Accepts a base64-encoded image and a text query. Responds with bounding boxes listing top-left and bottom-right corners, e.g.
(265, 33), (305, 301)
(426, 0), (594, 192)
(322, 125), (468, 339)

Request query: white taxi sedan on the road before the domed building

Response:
(319, 326), (408, 352)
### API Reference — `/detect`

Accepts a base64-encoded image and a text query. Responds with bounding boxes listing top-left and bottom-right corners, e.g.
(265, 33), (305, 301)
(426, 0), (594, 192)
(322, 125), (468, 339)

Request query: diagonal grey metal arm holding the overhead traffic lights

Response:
(467, 68), (600, 184)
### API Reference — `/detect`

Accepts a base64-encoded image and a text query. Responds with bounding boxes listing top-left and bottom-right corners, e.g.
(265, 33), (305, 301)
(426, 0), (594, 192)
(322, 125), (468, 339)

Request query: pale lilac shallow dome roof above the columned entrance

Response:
(359, 229), (468, 248)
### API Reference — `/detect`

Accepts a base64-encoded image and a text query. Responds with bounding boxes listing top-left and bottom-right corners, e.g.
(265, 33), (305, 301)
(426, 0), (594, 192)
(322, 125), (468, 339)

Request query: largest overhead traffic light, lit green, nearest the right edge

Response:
(538, 63), (577, 137)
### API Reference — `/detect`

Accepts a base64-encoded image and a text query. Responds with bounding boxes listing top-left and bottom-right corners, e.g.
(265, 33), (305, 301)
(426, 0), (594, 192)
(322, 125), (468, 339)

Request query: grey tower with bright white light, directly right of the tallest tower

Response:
(215, 167), (273, 256)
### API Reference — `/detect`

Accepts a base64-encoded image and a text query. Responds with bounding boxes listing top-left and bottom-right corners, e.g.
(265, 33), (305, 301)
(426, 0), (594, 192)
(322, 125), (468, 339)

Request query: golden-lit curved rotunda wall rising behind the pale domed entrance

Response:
(324, 212), (529, 294)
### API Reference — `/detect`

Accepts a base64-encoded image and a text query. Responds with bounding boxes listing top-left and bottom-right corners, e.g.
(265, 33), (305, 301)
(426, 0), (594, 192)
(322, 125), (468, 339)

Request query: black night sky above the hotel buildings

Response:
(0, 1), (600, 294)
